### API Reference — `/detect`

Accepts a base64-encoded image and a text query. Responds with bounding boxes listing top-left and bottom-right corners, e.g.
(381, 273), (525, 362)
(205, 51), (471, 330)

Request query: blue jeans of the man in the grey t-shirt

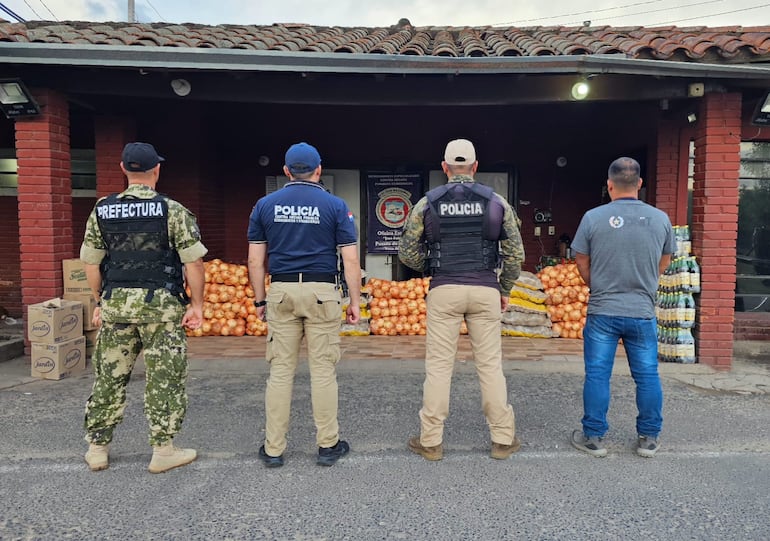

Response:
(582, 315), (663, 438)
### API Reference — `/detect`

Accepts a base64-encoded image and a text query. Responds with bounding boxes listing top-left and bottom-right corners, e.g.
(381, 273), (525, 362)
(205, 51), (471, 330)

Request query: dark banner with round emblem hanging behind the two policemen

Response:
(366, 173), (422, 254)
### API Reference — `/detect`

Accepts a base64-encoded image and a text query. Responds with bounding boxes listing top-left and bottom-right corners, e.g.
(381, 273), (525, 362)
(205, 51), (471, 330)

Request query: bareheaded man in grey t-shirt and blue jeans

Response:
(572, 158), (674, 457)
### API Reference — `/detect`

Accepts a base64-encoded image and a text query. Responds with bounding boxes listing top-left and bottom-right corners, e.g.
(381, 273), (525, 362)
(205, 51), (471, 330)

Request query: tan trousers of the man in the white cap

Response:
(420, 285), (515, 447)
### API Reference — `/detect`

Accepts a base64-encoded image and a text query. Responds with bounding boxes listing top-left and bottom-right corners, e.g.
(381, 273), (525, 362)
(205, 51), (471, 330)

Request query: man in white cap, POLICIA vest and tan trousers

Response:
(399, 139), (524, 460)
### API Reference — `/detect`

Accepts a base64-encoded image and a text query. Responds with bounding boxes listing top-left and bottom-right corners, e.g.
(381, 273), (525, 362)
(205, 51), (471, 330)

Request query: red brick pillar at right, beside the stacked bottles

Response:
(692, 93), (741, 369)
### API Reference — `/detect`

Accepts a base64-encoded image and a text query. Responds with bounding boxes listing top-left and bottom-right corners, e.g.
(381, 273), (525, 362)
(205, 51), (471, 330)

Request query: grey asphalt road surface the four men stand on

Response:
(0, 360), (770, 541)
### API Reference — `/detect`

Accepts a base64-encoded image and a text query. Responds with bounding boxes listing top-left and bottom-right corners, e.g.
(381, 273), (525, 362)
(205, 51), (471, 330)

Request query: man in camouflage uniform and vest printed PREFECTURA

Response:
(80, 143), (207, 473)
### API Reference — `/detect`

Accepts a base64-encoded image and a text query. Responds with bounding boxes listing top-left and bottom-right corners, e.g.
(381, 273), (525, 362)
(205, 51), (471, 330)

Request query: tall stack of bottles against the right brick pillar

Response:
(655, 225), (700, 363)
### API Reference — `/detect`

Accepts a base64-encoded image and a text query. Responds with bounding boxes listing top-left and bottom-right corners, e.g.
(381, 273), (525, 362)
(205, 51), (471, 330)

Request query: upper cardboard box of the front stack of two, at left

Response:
(27, 298), (83, 344)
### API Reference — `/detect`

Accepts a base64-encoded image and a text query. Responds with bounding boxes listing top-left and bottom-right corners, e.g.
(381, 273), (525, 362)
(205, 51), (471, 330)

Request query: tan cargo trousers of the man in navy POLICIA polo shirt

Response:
(265, 282), (342, 456)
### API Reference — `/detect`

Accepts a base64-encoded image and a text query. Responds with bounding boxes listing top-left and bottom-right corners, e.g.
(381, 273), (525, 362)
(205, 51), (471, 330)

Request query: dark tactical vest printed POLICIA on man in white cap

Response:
(425, 182), (499, 276)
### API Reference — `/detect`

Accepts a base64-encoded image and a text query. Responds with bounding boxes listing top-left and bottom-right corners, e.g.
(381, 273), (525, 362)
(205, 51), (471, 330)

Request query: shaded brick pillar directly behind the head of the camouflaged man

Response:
(94, 116), (136, 197)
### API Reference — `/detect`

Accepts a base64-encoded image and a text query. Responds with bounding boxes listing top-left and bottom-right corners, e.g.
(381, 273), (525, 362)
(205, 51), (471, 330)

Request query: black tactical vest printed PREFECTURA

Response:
(96, 194), (189, 304)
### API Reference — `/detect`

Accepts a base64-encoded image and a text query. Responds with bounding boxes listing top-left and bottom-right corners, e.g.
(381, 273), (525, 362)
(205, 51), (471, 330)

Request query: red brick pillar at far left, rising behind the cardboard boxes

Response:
(16, 90), (74, 306)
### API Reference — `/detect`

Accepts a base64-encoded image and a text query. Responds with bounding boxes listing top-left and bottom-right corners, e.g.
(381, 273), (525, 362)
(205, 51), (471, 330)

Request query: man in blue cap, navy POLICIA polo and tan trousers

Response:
(248, 143), (361, 467)
